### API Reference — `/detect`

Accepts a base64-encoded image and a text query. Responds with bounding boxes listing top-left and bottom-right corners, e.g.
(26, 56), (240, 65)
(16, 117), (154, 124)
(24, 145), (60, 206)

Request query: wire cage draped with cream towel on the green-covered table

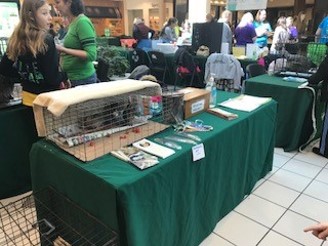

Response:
(34, 80), (182, 161)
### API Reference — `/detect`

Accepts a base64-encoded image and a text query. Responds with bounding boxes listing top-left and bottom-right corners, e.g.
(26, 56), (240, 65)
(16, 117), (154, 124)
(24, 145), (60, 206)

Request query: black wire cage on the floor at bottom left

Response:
(0, 188), (119, 246)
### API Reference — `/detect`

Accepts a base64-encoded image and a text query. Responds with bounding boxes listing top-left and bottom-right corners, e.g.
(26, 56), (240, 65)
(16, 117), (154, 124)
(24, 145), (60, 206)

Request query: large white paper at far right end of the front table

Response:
(219, 95), (271, 112)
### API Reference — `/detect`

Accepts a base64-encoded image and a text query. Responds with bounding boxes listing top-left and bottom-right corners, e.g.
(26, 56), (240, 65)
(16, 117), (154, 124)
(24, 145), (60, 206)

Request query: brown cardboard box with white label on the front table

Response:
(179, 87), (210, 119)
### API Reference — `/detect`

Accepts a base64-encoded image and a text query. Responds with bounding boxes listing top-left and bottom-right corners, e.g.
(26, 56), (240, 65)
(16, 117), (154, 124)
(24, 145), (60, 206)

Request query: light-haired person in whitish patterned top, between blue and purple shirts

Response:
(270, 16), (289, 54)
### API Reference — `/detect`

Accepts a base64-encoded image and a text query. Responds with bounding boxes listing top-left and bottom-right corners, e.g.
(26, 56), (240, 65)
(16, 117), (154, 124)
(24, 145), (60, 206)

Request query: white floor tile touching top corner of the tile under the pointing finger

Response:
(253, 181), (300, 208)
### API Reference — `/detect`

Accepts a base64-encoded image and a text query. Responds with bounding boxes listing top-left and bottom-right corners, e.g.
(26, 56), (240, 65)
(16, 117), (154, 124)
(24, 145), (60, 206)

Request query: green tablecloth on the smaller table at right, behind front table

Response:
(245, 75), (324, 151)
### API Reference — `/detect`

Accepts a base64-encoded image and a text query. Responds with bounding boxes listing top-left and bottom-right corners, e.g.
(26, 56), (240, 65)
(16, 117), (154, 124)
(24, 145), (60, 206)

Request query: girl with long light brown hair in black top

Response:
(0, 0), (67, 106)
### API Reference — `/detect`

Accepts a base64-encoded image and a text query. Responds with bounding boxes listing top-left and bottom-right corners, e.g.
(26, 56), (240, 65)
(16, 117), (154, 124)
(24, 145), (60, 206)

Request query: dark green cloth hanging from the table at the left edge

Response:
(0, 105), (38, 199)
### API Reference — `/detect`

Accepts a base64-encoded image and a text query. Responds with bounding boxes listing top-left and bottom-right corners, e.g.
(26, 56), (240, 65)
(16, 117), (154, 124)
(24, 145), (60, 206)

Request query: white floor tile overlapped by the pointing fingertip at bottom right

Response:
(273, 211), (322, 246)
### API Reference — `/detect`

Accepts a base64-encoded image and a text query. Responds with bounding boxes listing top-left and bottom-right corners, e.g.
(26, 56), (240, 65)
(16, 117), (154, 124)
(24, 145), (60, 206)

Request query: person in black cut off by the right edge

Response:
(308, 56), (328, 158)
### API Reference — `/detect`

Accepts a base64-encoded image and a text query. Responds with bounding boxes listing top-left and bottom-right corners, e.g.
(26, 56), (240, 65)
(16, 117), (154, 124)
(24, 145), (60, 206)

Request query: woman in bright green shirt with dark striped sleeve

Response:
(55, 0), (97, 86)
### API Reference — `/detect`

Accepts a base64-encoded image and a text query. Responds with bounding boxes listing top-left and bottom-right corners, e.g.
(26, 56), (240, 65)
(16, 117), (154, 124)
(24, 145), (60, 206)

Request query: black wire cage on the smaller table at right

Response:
(269, 42), (327, 78)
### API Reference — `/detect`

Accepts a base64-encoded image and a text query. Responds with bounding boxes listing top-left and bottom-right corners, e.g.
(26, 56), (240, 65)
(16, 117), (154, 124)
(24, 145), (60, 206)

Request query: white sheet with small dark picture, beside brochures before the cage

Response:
(132, 139), (175, 159)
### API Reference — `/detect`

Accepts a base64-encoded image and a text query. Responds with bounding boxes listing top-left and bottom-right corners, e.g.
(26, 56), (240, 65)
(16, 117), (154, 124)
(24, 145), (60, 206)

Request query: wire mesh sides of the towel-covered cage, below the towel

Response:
(43, 86), (183, 161)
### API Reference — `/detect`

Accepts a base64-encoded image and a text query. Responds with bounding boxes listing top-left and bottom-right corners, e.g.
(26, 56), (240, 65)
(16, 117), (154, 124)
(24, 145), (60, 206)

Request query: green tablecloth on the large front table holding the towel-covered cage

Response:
(30, 92), (277, 246)
